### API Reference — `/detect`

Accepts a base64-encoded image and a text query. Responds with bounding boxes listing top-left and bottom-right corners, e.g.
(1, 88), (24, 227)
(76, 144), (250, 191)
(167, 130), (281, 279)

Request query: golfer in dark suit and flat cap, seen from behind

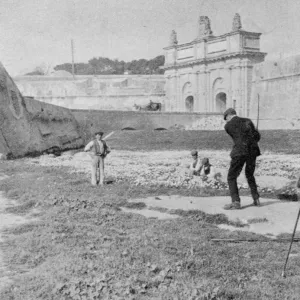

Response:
(224, 108), (261, 210)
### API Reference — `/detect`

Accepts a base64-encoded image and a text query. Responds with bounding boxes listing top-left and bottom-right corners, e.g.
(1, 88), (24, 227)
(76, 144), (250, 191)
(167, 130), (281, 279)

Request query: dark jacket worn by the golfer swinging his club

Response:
(225, 116), (261, 157)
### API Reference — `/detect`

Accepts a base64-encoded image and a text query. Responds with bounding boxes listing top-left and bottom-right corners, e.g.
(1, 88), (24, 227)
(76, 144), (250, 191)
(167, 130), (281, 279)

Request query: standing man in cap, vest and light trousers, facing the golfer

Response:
(84, 132), (110, 186)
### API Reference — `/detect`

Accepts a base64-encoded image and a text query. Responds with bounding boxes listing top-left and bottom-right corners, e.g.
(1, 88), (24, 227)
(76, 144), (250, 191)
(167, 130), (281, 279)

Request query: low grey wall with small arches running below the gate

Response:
(72, 109), (224, 142)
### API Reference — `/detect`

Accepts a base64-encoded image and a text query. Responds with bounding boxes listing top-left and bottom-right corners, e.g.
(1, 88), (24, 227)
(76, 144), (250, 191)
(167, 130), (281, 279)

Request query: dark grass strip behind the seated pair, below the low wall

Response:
(108, 130), (300, 154)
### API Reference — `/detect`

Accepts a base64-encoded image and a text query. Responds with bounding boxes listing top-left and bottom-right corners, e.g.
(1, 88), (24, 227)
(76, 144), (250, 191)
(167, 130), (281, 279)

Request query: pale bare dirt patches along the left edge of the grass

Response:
(0, 174), (36, 290)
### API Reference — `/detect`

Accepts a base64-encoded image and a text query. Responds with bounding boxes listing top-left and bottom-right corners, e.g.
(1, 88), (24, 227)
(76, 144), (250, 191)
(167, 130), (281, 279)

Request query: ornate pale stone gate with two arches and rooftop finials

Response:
(163, 14), (266, 116)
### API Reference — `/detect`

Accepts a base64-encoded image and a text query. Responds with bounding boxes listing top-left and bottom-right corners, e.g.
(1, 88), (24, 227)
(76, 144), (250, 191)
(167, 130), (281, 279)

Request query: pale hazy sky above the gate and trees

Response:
(0, 0), (300, 76)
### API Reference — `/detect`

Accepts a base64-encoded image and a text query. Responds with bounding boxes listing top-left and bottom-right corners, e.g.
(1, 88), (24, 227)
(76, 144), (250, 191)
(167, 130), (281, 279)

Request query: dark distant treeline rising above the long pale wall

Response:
(26, 55), (165, 75)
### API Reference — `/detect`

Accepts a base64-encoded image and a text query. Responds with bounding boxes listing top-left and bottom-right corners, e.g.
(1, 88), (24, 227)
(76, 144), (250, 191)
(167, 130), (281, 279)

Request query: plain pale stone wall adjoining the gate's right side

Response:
(250, 55), (300, 129)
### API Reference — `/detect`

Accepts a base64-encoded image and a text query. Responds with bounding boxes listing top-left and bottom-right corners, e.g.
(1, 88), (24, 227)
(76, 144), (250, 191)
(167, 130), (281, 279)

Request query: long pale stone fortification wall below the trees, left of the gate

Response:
(14, 73), (165, 110)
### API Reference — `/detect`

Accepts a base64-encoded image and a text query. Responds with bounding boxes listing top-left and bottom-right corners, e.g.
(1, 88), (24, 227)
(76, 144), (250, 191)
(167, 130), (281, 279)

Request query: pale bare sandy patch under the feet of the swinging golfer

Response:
(125, 195), (300, 237)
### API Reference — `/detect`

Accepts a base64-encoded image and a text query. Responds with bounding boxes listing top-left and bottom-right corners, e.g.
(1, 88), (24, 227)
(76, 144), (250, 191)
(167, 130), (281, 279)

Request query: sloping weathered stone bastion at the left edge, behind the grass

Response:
(0, 64), (82, 157)
